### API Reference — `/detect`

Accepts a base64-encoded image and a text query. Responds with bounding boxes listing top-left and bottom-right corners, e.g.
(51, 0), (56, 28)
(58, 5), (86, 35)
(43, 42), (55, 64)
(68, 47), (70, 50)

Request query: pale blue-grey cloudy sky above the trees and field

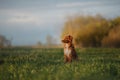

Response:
(0, 0), (120, 45)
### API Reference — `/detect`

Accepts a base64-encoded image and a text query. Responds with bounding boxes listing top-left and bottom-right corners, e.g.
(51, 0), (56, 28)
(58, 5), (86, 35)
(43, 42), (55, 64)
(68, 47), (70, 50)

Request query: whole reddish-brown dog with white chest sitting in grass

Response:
(62, 35), (78, 63)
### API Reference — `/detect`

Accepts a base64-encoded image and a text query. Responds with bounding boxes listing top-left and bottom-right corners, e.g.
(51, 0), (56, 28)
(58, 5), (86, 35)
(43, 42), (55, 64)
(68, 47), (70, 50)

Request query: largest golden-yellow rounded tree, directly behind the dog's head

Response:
(62, 15), (109, 47)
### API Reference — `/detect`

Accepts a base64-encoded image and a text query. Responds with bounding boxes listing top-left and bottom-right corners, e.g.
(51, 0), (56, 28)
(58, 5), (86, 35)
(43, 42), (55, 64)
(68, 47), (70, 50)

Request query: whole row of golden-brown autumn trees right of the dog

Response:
(61, 15), (120, 47)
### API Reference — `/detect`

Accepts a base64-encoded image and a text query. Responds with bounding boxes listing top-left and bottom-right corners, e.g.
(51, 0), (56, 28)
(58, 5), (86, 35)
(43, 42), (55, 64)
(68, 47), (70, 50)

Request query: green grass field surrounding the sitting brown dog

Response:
(0, 48), (120, 80)
